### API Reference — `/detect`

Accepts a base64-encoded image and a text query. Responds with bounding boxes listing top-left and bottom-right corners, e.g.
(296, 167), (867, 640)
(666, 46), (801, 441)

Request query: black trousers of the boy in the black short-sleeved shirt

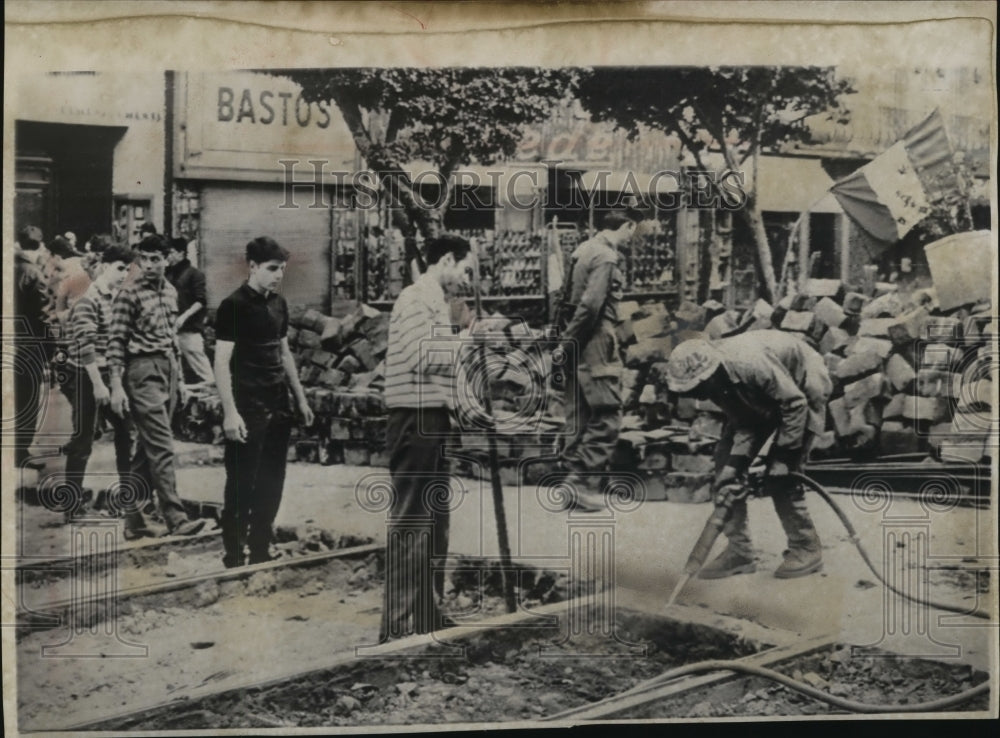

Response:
(220, 392), (292, 566)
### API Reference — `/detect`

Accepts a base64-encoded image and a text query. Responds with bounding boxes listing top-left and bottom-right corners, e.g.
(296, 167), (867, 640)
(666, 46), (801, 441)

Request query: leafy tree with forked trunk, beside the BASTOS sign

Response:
(271, 67), (577, 238)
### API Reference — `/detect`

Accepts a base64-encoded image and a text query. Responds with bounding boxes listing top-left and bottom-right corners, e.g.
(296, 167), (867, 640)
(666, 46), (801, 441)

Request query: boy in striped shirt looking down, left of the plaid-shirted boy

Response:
(61, 246), (132, 509)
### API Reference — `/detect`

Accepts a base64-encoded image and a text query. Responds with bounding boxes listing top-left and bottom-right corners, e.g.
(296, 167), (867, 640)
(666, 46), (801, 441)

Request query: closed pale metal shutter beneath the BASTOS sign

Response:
(199, 183), (331, 310)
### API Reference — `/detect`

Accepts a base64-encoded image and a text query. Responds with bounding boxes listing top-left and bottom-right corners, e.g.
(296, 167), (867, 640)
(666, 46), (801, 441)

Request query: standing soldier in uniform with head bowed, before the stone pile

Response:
(561, 210), (640, 510)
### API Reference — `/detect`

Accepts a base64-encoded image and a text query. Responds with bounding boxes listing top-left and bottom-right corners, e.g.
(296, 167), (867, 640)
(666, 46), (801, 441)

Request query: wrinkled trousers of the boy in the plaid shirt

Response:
(123, 354), (187, 531)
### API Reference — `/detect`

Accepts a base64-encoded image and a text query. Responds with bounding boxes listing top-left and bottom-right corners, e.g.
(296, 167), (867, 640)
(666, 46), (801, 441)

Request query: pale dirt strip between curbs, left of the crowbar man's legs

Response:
(17, 548), (381, 730)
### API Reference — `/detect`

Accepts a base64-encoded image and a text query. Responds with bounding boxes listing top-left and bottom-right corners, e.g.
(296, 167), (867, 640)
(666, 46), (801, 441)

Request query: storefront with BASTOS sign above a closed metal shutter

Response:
(172, 72), (365, 310)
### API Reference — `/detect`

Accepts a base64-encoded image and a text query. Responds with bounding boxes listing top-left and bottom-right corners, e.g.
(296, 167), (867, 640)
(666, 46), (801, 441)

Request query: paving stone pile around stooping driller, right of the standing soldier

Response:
(614, 279), (997, 501)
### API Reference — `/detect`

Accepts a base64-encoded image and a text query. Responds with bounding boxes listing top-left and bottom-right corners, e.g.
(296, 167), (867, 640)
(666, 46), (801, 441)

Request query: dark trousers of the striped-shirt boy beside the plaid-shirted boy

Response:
(60, 366), (132, 498)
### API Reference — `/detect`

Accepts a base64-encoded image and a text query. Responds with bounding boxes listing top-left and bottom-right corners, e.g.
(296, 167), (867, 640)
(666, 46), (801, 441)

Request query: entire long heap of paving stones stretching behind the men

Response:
(179, 272), (996, 484)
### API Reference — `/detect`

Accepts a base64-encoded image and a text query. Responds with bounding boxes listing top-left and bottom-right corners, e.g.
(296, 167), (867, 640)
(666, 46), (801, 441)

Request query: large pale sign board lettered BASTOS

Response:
(174, 72), (358, 183)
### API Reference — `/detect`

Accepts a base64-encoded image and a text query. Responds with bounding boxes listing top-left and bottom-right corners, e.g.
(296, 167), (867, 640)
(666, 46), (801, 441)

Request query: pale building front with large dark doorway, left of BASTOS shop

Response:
(10, 72), (167, 244)
